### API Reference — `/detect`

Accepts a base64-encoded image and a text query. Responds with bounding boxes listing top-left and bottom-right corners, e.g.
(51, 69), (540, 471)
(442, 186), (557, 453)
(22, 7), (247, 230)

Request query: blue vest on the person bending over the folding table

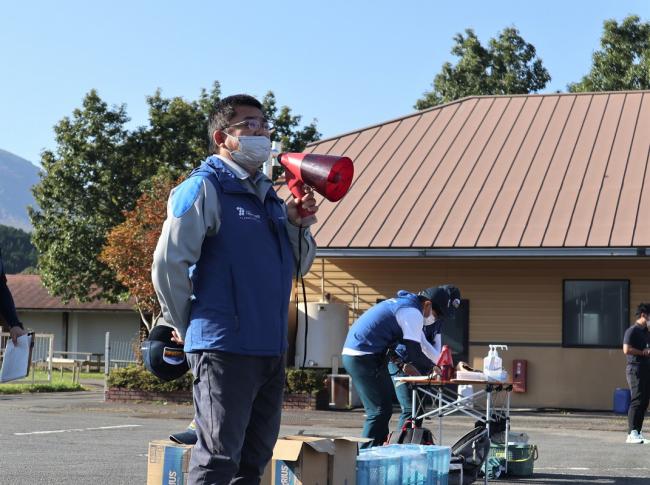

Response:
(344, 290), (422, 354)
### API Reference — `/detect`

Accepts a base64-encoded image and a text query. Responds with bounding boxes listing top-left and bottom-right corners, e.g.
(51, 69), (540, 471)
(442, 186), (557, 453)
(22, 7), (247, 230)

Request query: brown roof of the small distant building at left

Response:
(7, 275), (134, 312)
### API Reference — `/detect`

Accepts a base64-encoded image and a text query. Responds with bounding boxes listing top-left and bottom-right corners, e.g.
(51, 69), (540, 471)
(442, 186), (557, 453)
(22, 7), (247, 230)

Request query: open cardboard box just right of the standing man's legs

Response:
(267, 436), (367, 485)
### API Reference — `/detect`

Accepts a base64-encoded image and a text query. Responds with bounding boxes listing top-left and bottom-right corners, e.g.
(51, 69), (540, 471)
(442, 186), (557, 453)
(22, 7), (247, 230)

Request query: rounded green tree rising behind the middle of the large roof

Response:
(415, 27), (551, 110)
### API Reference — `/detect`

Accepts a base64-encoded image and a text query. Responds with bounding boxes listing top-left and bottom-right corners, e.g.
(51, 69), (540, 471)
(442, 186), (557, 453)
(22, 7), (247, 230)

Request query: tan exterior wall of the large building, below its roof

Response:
(298, 258), (650, 409)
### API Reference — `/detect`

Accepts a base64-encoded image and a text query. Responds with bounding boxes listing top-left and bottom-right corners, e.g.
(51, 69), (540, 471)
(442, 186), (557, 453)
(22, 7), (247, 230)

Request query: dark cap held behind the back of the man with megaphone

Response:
(141, 325), (190, 381)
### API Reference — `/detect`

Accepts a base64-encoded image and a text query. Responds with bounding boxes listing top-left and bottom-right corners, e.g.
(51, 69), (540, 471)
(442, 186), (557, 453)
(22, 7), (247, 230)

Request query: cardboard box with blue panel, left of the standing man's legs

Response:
(147, 440), (192, 485)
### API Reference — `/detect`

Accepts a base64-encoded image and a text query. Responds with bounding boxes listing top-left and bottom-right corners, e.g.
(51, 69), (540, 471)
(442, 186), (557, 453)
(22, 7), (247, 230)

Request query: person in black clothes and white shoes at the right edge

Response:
(623, 303), (650, 444)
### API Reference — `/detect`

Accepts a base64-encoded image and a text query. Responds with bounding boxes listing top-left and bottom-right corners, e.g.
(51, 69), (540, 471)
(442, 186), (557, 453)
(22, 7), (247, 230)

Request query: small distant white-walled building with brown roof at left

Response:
(7, 275), (140, 358)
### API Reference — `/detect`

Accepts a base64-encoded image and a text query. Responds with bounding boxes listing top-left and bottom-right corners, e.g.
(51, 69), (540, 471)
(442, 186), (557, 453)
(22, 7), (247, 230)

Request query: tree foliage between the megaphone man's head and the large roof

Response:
(262, 91), (321, 152)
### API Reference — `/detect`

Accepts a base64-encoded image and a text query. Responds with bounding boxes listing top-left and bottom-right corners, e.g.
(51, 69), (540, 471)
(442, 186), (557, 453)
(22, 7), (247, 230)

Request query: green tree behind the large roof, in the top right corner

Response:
(568, 15), (650, 93)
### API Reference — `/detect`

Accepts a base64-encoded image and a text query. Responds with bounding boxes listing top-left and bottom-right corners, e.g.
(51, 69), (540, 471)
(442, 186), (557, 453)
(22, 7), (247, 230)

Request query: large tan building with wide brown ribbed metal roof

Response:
(280, 91), (650, 409)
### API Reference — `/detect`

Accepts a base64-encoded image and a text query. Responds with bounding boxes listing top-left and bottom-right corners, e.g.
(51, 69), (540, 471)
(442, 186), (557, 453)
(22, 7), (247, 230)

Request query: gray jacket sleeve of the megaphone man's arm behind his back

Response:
(151, 179), (221, 338)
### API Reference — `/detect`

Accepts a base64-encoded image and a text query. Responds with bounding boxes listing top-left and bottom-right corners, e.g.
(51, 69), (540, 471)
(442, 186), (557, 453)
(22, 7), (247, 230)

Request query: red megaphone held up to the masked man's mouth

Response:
(278, 153), (354, 217)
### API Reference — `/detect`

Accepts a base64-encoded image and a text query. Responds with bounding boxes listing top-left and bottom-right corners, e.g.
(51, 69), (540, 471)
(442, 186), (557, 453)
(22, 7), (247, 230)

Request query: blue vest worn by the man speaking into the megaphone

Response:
(185, 157), (294, 356)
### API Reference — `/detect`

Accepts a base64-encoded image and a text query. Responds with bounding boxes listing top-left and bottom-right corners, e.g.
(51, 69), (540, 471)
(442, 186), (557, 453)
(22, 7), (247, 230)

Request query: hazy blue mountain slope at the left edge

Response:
(0, 149), (39, 231)
